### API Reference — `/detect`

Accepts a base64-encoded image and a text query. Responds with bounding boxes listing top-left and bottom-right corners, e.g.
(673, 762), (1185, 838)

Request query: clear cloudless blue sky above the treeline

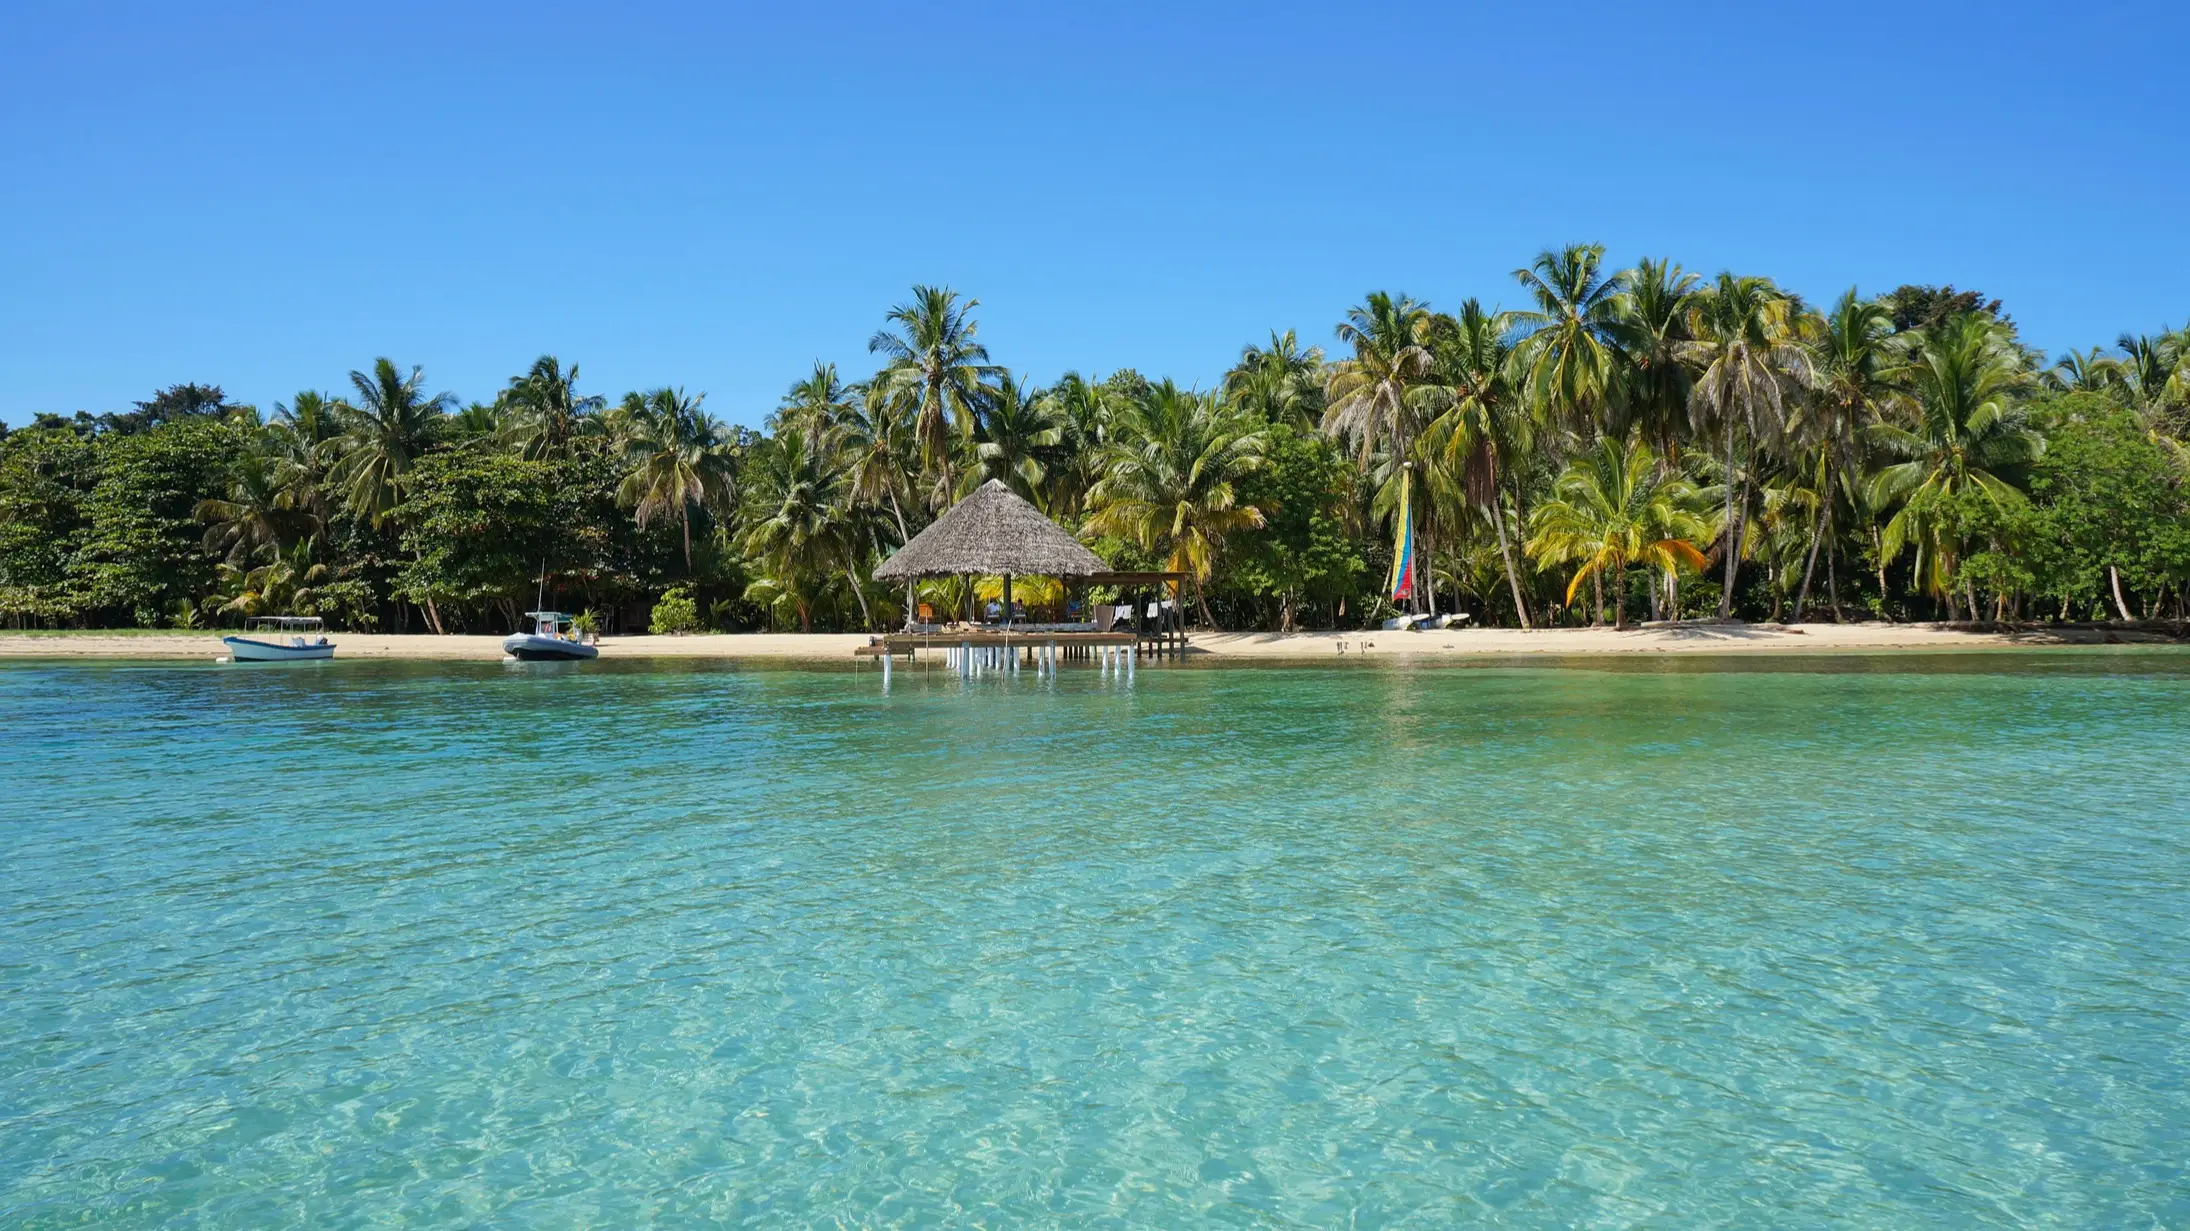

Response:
(0, 0), (2190, 423)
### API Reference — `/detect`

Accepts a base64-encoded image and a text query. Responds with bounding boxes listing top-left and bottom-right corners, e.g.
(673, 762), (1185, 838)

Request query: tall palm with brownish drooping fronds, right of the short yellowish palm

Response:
(1680, 274), (1809, 620)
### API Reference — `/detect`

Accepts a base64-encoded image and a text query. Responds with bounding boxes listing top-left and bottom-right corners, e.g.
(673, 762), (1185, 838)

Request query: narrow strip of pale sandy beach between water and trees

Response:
(0, 624), (2183, 664)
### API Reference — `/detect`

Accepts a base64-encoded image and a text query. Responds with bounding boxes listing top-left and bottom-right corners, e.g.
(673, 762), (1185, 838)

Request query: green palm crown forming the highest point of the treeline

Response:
(1513, 243), (1632, 429)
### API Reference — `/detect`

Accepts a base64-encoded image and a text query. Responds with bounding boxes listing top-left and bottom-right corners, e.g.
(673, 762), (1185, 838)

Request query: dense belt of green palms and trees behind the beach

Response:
(0, 254), (2190, 633)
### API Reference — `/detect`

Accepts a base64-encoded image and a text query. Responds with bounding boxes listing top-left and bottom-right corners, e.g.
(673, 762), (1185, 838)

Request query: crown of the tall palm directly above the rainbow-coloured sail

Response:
(1323, 291), (1434, 469)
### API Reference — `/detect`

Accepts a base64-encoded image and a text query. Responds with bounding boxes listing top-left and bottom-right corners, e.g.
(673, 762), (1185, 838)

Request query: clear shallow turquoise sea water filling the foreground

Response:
(0, 653), (2190, 1229)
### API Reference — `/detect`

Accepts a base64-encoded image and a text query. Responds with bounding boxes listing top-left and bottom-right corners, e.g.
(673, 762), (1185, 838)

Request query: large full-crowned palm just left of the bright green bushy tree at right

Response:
(1866, 311), (2045, 618)
